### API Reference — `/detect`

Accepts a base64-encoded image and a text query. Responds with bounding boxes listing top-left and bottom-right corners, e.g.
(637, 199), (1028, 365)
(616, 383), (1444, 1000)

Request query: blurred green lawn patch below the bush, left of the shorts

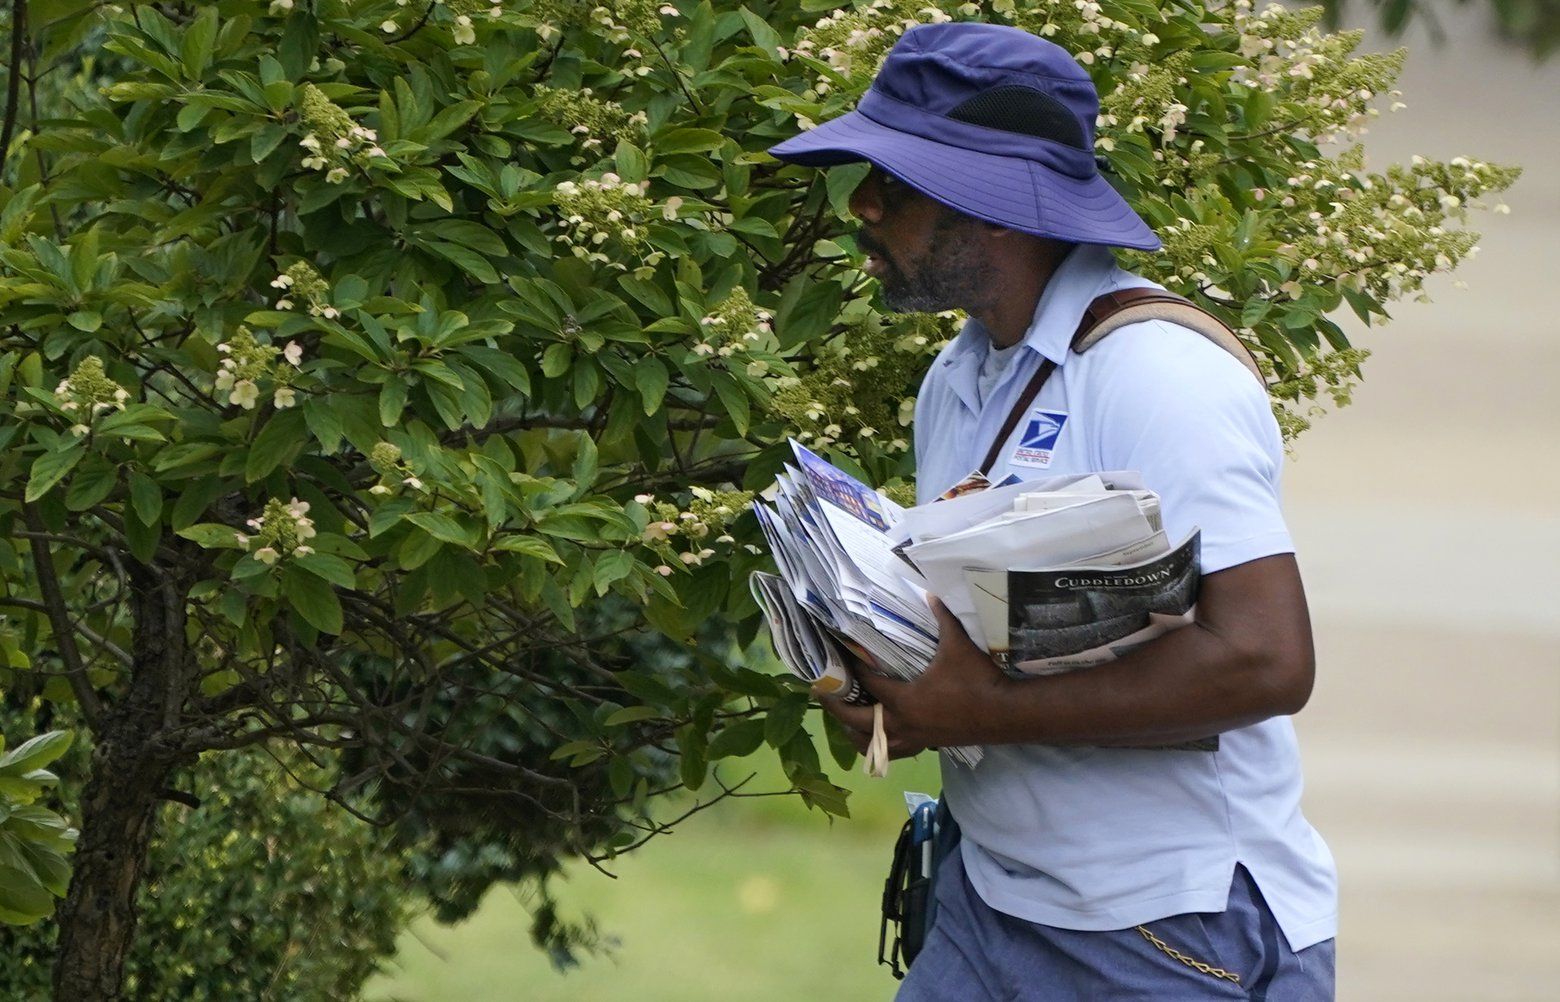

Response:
(365, 752), (939, 1002)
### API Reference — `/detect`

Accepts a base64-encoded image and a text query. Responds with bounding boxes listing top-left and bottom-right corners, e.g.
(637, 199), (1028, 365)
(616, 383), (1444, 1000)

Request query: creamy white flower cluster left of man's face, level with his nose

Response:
(552, 172), (666, 276)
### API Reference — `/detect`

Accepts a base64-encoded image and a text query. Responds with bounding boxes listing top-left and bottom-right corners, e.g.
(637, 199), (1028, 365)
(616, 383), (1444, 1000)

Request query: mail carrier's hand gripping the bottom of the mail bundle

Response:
(824, 598), (1014, 759)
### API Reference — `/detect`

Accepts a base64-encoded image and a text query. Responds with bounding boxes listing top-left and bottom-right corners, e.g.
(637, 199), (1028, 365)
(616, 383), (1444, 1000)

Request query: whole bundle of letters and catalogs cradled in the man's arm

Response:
(752, 442), (1198, 765)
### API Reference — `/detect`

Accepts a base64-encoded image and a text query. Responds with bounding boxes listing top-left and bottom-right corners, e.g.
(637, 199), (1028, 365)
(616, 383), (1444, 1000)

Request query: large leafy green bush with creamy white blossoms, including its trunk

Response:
(0, 0), (1515, 999)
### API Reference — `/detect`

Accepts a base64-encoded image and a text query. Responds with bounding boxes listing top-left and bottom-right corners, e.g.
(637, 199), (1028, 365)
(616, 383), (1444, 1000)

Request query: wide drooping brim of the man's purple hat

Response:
(769, 111), (1161, 250)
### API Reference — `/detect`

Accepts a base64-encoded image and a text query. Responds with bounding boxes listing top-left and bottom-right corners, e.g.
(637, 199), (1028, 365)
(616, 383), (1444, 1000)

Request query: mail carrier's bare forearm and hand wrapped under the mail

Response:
(828, 554), (1315, 751)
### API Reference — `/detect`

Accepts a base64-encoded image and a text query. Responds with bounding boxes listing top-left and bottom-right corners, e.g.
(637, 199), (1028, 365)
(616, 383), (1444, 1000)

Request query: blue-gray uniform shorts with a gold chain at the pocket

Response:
(895, 851), (1334, 1002)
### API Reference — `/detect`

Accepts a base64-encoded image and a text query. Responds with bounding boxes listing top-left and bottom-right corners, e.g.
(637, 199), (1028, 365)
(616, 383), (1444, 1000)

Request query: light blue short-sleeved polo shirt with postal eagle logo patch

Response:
(914, 245), (1337, 950)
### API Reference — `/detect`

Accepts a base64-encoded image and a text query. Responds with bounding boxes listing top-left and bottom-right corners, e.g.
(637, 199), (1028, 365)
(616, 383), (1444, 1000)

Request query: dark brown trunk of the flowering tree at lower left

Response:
(55, 565), (187, 1002)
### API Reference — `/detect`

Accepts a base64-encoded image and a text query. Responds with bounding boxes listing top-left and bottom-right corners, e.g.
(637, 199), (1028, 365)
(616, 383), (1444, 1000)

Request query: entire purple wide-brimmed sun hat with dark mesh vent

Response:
(769, 23), (1159, 250)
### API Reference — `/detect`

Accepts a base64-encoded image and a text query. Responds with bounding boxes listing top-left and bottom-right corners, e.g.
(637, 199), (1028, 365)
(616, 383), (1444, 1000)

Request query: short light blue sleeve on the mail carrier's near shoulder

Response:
(1089, 320), (1295, 574)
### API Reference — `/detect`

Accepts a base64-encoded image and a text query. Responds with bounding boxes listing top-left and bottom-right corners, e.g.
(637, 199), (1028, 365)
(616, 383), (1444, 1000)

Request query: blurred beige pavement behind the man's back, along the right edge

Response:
(1285, 5), (1560, 1002)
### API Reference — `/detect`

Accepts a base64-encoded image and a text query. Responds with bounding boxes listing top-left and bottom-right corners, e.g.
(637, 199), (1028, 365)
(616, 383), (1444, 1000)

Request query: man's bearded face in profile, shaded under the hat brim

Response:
(850, 167), (989, 312)
